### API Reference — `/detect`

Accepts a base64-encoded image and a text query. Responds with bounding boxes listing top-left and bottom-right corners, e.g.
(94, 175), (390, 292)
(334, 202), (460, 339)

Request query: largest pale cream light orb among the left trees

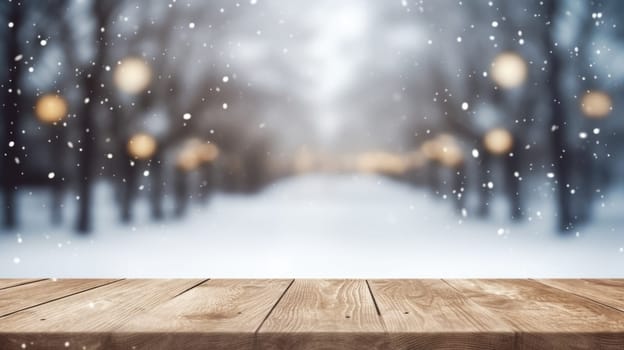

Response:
(113, 57), (152, 94)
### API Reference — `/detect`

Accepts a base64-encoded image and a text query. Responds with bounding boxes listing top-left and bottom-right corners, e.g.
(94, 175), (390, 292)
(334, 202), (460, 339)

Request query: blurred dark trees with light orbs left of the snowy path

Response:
(2, 0), (288, 232)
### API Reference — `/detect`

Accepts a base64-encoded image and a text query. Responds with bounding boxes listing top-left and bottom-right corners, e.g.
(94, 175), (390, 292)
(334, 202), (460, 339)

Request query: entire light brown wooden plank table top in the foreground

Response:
(0, 279), (624, 350)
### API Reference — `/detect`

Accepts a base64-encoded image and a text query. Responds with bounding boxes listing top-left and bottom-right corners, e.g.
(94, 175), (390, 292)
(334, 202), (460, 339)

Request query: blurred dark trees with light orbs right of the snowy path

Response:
(390, 0), (624, 232)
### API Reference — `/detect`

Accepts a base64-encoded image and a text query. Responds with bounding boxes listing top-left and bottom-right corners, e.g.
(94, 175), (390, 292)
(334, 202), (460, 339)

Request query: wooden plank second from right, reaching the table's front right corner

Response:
(447, 280), (624, 349)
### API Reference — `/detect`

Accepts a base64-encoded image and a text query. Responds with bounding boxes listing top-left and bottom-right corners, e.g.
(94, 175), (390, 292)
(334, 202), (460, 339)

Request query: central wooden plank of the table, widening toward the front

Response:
(257, 280), (387, 349)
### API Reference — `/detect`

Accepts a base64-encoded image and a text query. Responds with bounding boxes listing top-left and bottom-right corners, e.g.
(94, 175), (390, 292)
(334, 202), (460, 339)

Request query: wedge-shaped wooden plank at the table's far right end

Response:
(538, 279), (624, 311)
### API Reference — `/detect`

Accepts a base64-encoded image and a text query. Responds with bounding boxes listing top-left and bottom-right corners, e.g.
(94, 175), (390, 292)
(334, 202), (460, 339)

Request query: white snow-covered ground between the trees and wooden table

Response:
(0, 175), (624, 278)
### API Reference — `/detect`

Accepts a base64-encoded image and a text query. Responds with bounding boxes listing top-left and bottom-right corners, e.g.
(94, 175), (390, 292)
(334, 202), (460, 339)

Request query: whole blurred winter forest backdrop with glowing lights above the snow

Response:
(0, 0), (624, 235)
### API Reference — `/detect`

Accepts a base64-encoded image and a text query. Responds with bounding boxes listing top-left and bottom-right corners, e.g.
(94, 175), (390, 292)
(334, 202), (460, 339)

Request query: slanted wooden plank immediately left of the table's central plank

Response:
(113, 280), (292, 350)
